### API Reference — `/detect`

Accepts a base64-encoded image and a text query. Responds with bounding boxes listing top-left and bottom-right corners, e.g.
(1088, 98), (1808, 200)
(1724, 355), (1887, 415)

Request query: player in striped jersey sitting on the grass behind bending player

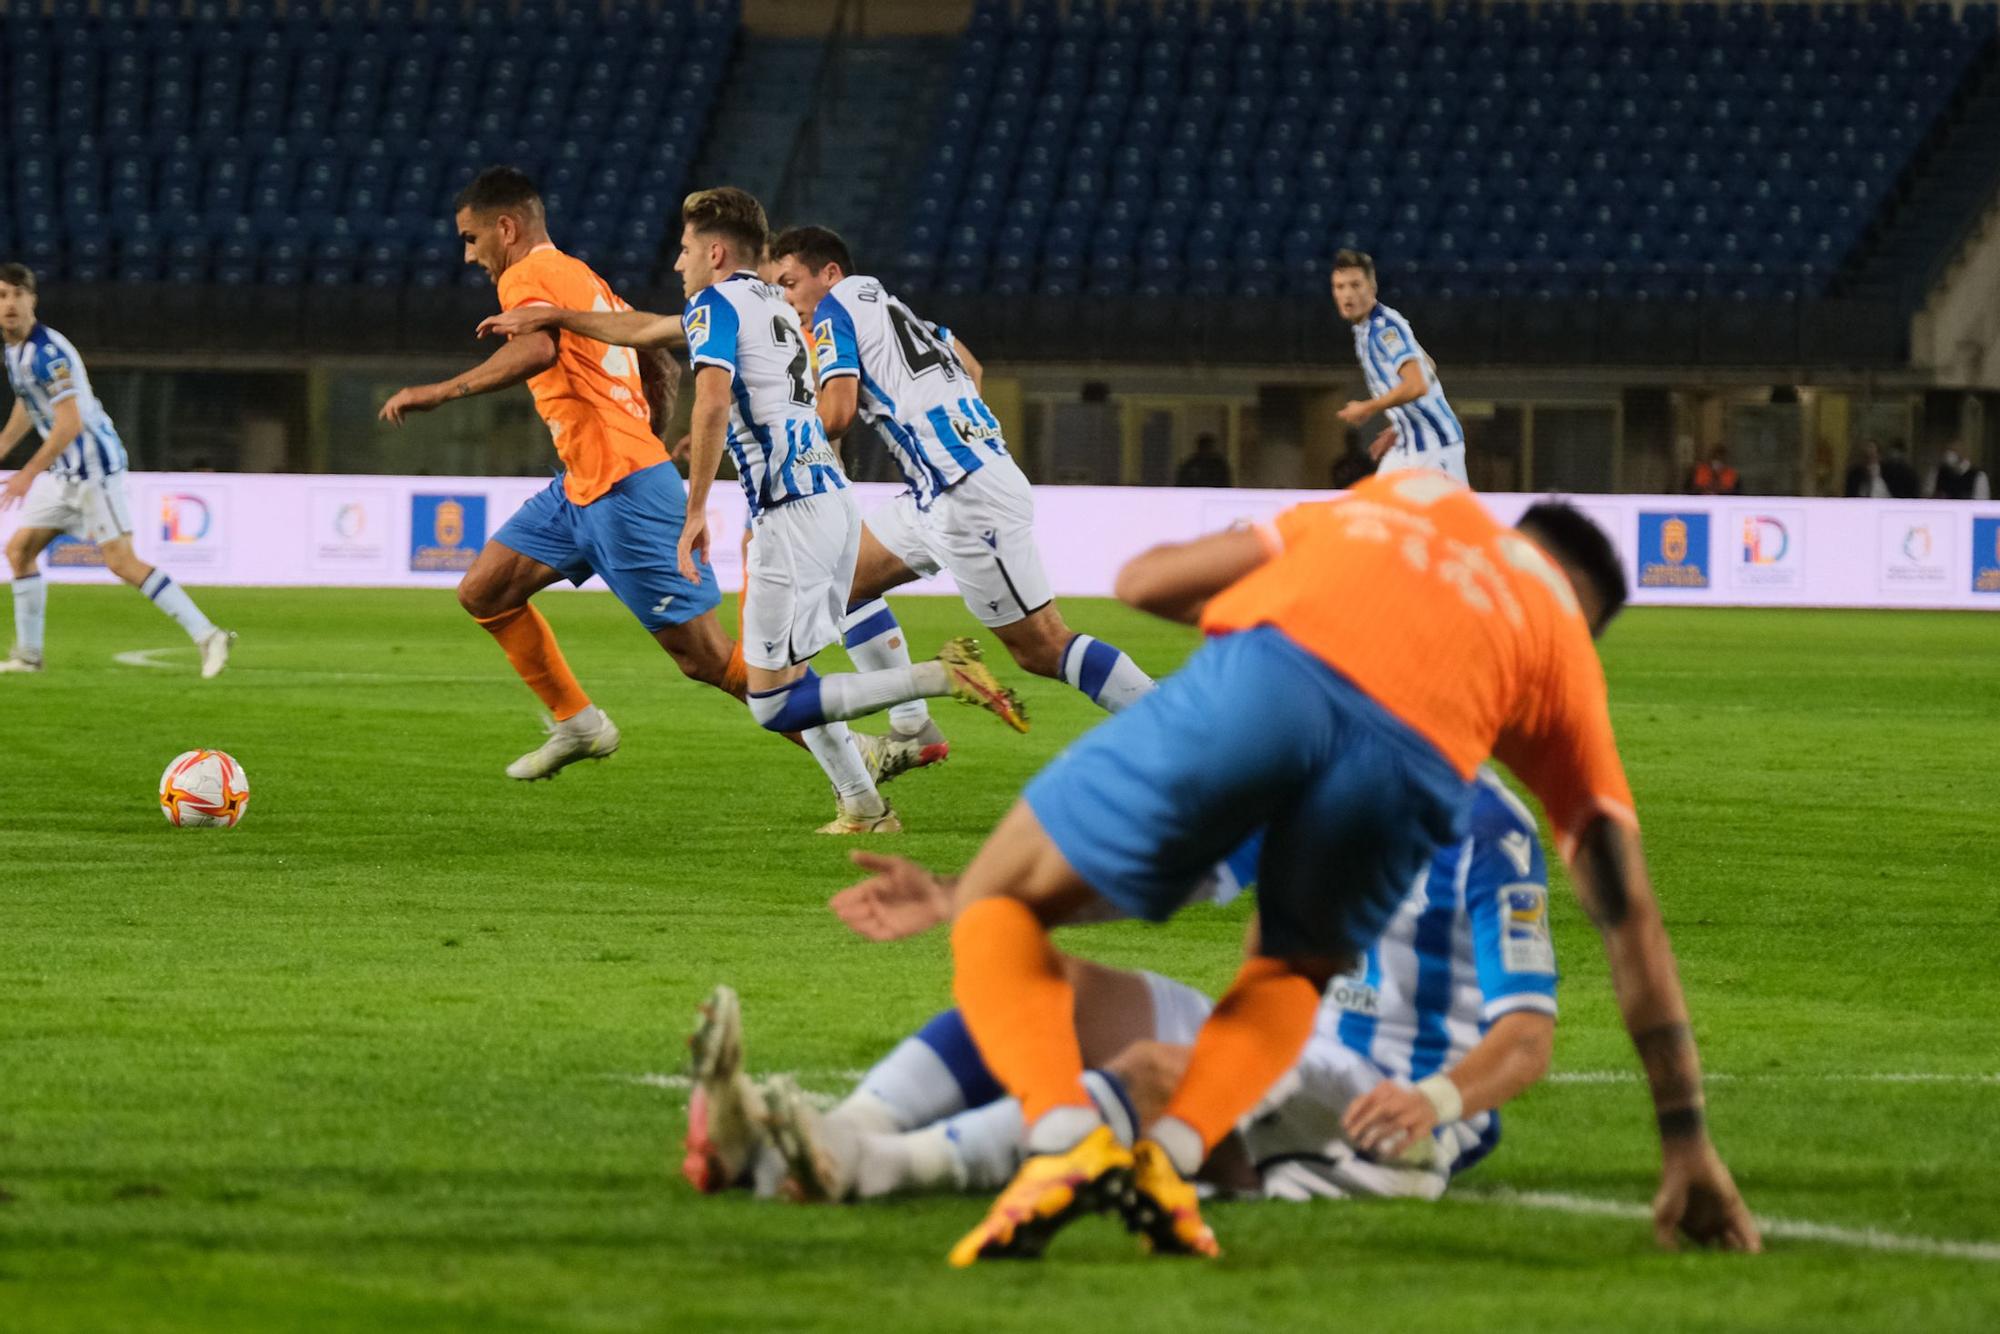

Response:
(682, 772), (1556, 1200)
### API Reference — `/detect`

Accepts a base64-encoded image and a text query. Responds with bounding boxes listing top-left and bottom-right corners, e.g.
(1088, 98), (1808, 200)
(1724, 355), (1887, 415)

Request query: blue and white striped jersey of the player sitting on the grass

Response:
(1318, 770), (1556, 1082)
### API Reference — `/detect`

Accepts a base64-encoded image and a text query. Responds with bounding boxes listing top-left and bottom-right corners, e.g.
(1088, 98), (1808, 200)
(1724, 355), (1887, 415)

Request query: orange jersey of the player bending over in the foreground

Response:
(1202, 470), (1634, 856)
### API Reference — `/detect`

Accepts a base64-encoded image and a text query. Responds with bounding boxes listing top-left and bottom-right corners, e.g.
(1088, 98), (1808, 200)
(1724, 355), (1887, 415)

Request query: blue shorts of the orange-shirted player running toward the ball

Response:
(494, 464), (722, 630)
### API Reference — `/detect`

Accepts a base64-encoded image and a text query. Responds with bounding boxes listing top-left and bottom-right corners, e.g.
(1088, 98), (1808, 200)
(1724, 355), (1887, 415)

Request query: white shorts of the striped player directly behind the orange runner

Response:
(744, 490), (862, 672)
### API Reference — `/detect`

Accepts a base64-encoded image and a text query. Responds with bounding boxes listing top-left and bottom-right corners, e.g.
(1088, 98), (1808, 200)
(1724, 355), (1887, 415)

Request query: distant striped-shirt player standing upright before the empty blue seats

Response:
(1332, 250), (1466, 482)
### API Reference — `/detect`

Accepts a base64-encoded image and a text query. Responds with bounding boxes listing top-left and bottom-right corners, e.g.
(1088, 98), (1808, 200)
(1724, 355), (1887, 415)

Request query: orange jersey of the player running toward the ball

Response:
(500, 246), (666, 504)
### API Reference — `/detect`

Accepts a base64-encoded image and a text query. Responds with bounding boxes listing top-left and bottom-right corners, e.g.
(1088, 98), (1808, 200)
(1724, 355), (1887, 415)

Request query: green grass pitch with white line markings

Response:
(0, 586), (2000, 1334)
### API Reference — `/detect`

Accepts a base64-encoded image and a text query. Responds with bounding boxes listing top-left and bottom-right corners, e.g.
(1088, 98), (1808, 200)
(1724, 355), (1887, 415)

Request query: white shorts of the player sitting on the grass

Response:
(1236, 1034), (1492, 1200)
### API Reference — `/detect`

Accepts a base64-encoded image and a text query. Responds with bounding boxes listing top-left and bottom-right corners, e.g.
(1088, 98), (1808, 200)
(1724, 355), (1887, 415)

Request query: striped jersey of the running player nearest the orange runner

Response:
(680, 270), (848, 518)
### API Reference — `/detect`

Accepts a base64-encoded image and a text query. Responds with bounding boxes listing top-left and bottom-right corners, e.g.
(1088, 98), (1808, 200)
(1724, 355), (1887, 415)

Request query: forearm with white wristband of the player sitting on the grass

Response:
(1340, 1010), (1556, 1156)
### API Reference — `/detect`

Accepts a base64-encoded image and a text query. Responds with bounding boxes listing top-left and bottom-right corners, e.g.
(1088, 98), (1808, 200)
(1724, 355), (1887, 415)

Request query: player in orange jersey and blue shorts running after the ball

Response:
(382, 166), (744, 780)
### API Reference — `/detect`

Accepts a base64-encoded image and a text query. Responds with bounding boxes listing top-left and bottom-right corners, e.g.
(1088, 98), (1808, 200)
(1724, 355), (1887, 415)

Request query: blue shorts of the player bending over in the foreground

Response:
(1024, 626), (1472, 958)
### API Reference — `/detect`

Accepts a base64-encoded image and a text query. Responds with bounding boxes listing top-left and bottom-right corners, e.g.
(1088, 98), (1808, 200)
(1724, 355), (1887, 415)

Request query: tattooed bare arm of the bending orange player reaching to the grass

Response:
(1570, 816), (1764, 1252)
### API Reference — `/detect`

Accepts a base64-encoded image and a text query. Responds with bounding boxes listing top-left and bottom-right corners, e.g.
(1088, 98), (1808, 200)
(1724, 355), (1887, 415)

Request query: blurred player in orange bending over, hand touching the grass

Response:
(836, 472), (1758, 1264)
